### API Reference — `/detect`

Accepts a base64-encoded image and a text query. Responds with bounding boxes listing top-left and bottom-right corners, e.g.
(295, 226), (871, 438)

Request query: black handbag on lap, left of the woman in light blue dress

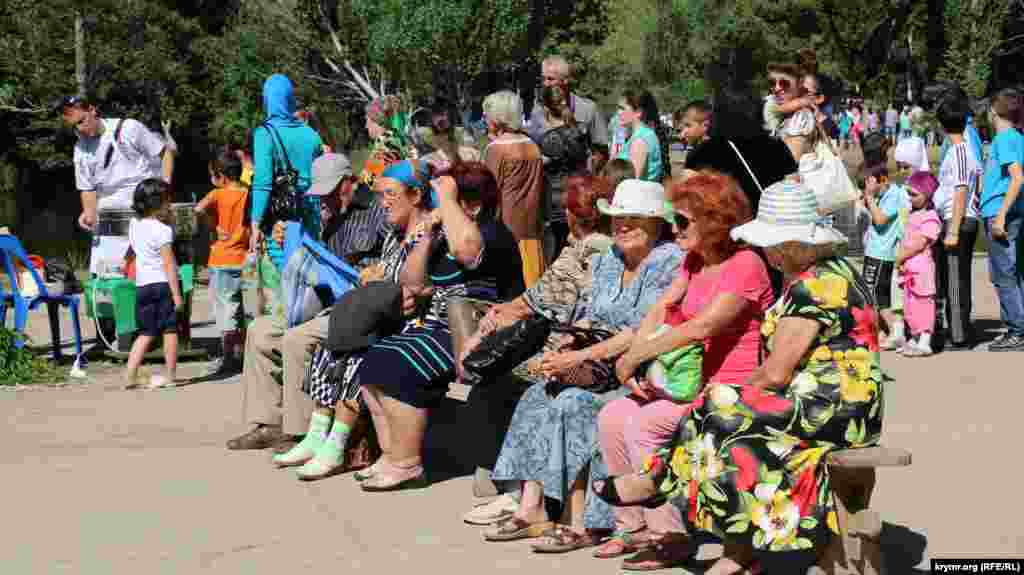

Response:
(462, 313), (552, 386)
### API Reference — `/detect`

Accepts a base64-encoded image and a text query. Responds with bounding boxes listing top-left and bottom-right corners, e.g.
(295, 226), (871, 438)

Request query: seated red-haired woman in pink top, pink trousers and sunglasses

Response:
(595, 173), (772, 570)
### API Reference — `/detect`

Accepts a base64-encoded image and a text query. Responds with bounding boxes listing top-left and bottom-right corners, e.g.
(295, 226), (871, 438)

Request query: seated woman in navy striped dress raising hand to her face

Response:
(354, 163), (523, 491)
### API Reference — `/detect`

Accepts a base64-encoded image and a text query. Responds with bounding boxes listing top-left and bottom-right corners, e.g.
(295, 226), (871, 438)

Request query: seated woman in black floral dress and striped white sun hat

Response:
(594, 182), (883, 575)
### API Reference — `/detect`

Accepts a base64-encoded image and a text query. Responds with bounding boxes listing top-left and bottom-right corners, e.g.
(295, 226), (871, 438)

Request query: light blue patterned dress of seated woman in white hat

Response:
(492, 242), (683, 529)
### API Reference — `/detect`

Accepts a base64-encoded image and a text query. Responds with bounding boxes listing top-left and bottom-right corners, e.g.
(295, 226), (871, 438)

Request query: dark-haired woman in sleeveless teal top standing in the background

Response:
(617, 88), (664, 182)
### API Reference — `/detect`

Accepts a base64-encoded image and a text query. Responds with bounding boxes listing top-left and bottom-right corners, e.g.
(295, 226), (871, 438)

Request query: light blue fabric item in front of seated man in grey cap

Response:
(281, 222), (359, 327)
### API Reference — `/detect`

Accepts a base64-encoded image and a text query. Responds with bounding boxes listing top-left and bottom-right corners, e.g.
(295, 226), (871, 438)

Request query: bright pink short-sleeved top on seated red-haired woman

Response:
(666, 250), (772, 385)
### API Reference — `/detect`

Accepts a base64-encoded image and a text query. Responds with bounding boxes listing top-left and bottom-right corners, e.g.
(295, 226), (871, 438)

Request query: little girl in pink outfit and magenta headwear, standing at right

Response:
(896, 172), (942, 357)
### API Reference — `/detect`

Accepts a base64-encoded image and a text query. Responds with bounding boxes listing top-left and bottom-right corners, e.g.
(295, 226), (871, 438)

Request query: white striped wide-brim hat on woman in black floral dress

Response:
(730, 181), (847, 248)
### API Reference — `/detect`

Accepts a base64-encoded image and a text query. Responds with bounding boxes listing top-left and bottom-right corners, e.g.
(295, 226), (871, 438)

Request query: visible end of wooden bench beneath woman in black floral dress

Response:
(807, 446), (911, 575)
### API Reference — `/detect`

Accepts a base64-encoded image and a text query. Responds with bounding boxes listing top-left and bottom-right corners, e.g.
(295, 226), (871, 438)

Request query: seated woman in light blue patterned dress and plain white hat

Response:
(485, 180), (682, 551)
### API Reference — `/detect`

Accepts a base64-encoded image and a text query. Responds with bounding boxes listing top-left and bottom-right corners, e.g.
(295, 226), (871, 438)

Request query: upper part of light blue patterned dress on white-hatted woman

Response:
(577, 242), (684, 331)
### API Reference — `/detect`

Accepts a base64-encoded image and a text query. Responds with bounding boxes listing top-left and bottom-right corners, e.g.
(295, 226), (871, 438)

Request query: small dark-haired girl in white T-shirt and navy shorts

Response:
(125, 178), (183, 388)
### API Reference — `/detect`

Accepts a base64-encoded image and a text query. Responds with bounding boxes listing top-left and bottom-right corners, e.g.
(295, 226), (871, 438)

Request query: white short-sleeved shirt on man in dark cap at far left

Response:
(74, 118), (164, 210)
